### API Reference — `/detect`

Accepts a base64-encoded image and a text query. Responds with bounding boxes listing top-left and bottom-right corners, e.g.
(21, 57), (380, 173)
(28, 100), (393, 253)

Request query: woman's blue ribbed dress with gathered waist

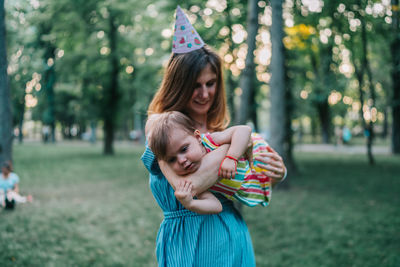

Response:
(142, 147), (255, 267)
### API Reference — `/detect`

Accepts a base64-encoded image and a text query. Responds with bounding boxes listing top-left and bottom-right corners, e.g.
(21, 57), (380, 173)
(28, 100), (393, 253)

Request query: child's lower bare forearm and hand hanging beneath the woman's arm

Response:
(175, 181), (222, 214)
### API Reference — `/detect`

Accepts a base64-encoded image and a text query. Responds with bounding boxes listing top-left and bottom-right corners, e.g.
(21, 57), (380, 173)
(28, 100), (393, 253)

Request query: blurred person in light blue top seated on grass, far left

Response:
(0, 161), (32, 209)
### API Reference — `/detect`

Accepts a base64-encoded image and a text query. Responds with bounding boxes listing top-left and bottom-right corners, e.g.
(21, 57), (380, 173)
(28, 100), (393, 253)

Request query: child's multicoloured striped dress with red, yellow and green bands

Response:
(202, 133), (271, 207)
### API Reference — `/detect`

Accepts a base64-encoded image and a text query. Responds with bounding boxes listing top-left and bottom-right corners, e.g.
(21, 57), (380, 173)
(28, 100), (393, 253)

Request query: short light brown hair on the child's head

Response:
(148, 111), (196, 160)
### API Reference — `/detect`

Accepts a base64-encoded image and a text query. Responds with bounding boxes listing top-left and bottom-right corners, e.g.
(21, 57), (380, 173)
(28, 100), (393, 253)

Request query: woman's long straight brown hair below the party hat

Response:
(147, 46), (230, 131)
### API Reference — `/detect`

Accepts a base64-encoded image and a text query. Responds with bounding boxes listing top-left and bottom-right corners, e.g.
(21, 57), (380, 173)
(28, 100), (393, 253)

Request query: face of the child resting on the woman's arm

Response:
(166, 128), (206, 175)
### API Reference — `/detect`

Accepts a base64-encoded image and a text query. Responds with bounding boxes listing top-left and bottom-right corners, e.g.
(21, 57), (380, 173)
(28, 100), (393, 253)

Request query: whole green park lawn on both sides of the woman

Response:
(0, 143), (400, 267)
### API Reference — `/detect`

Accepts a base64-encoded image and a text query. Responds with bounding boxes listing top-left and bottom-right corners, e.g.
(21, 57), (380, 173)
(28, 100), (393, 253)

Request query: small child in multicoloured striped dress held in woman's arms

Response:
(148, 111), (271, 214)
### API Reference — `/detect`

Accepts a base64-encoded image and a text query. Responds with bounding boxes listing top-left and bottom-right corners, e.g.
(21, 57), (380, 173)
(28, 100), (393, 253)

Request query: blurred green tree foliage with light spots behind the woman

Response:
(6, 0), (392, 146)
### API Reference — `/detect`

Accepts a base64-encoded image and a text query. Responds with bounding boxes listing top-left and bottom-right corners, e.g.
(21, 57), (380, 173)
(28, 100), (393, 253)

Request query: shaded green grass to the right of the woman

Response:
(245, 154), (400, 266)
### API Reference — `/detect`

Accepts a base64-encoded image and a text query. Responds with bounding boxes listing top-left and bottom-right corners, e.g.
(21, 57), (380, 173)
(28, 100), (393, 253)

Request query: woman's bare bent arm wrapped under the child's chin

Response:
(158, 145), (229, 196)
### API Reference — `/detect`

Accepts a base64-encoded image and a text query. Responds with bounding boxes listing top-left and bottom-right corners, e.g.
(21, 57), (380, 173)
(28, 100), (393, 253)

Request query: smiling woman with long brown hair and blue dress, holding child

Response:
(142, 7), (285, 267)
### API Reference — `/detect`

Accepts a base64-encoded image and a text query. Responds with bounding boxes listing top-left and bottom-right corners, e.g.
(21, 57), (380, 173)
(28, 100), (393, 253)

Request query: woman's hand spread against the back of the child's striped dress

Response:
(255, 146), (286, 182)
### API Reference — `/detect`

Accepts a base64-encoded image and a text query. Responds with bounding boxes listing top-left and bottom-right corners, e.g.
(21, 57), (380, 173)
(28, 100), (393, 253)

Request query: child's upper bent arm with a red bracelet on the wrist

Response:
(210, 125), (252, 178)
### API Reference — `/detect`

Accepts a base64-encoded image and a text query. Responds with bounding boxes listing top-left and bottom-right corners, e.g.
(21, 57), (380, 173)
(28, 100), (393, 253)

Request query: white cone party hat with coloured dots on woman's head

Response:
(172, 6), (204, 54)
